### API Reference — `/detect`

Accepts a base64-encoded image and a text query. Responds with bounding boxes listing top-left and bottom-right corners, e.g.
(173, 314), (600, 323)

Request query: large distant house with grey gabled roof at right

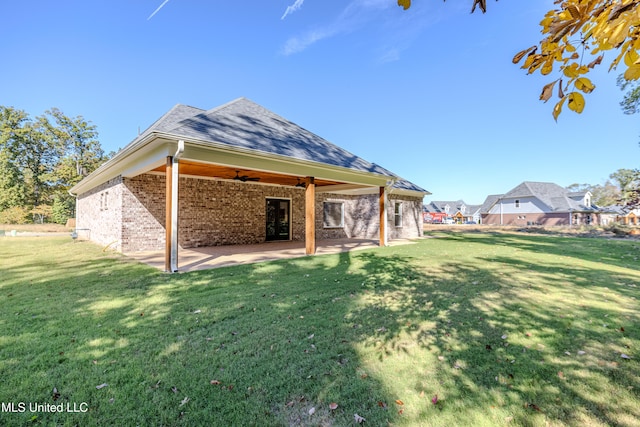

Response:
(481, 182), (600, 225)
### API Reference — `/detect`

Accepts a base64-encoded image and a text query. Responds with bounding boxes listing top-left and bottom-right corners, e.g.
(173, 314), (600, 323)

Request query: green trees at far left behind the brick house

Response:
(0, 106), (113, 224)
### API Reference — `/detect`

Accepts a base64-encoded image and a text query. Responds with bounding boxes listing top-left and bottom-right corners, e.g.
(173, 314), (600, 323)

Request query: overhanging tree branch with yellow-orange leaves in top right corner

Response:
(398, 0), (640, 120)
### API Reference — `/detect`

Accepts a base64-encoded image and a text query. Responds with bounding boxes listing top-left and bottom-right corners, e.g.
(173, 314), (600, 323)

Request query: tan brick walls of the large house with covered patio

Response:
(78, 174), (422, 252)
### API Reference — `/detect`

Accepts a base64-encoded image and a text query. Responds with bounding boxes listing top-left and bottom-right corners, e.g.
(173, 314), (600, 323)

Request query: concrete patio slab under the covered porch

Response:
(125, 239), (412, 272)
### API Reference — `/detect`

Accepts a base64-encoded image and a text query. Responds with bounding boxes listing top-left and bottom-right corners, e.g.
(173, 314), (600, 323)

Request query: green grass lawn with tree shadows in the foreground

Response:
(0, 232), (640, 426)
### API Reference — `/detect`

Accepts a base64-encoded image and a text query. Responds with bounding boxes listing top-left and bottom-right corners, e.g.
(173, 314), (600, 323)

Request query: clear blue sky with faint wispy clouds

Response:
(0, 0), (640, 204)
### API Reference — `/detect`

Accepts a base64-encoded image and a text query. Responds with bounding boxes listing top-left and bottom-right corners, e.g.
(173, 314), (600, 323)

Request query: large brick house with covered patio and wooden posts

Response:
(71, 98), (430, 271)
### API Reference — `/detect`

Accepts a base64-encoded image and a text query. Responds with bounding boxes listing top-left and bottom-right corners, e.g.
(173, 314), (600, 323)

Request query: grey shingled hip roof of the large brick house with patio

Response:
(71, 98), (430, 194)
